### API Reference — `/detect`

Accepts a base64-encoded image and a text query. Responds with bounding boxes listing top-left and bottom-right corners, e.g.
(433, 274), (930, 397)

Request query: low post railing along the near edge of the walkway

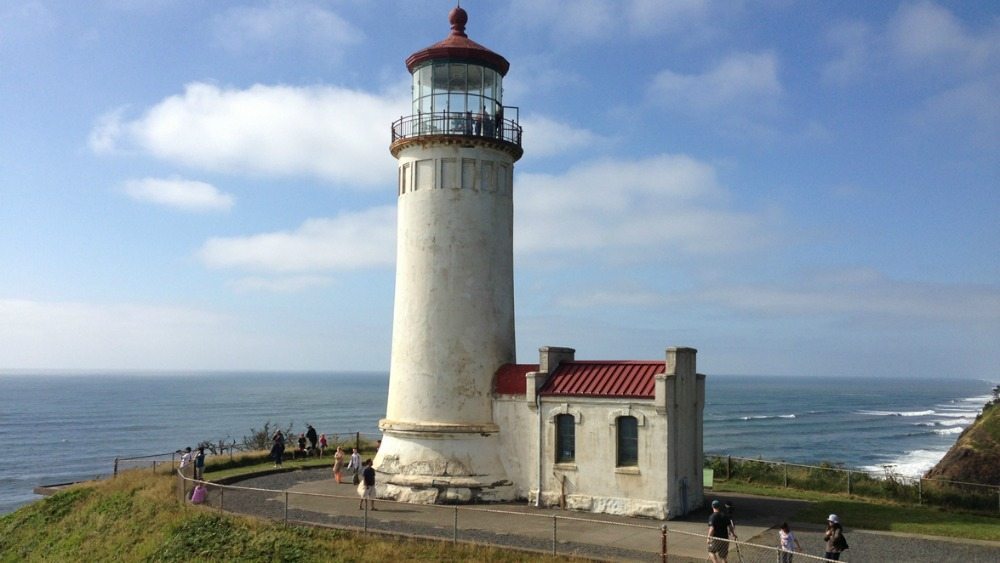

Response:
(176, 471), (825, 562)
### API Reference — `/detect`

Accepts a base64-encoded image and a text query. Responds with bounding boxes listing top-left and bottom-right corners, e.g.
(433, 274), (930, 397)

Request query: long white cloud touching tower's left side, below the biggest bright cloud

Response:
(198, 206), (396, 273)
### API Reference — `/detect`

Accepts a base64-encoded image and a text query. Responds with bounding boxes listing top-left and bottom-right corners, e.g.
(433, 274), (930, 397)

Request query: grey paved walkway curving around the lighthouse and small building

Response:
(210, 469), (1000, 563)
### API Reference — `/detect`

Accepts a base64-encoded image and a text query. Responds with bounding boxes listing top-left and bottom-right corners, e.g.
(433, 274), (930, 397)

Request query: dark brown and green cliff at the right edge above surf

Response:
(925, 386), (1000, 485)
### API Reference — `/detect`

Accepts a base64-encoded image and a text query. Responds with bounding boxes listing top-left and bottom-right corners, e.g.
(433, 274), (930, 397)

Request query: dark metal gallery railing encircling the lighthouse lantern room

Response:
(392, 111), (522, 147)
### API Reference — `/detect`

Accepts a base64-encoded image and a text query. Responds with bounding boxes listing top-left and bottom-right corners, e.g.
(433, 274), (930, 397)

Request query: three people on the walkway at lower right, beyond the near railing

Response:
(707, 499), (848, 563)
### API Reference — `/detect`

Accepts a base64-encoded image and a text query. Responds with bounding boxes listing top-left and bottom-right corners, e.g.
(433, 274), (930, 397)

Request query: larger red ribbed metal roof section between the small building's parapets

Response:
(539, 360), (666, 399)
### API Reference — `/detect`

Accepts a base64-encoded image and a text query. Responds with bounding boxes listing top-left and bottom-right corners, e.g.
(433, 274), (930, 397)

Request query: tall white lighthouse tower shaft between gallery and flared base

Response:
(386, 144), (515, 430)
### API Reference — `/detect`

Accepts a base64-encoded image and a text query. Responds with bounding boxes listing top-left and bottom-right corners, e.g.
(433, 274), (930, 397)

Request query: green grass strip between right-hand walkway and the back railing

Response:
(714, 480), (1000, 541)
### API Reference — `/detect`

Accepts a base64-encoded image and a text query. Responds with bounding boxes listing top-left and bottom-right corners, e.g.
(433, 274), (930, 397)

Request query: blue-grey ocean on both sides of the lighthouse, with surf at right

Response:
(0, 371), (995, 514)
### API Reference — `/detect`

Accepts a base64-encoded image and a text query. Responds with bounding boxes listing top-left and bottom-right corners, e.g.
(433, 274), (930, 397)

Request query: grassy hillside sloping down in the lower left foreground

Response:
(0, 471), (574, 562)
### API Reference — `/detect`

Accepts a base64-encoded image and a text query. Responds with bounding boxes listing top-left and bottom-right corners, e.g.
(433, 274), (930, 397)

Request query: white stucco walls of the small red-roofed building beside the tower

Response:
(494, 349), (705, 519)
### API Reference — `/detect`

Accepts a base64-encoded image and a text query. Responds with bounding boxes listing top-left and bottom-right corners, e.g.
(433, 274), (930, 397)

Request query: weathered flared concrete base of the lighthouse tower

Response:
(377, 429), (515, 504)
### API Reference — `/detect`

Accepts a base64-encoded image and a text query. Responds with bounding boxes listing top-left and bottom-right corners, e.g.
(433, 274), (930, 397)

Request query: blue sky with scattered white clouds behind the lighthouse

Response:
(0, 0), (1000, 380)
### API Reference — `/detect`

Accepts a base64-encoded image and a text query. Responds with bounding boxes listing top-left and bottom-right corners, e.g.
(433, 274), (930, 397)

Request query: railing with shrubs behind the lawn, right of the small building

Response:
(705, 454), (1000, 512)
